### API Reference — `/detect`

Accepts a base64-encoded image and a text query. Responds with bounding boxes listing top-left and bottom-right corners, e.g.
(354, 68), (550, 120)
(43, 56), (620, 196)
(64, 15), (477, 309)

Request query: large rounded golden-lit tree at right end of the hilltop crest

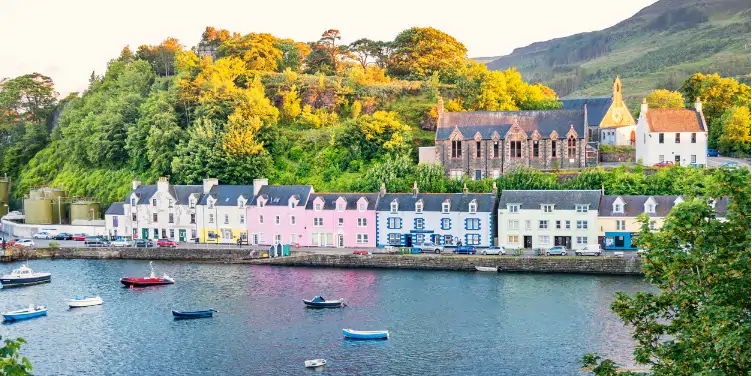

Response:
(387, 27), (467, 81)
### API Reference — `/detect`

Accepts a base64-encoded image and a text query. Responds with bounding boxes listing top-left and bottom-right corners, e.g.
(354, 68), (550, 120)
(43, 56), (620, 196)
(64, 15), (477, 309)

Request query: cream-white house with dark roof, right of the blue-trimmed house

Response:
(498, 190), (601, 249)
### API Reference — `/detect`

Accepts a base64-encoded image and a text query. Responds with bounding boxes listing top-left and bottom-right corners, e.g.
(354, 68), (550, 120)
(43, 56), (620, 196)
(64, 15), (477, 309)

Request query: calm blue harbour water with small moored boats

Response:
(0, 260), (649, 375)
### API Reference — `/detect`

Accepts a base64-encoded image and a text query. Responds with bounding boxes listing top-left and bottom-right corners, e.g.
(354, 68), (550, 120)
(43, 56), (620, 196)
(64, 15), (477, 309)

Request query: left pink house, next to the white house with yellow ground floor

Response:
(246, 185), (313, 245)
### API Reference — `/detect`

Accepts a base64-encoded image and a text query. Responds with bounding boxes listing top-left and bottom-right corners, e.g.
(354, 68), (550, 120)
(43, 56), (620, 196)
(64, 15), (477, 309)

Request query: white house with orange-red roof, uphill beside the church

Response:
(635, 97), (708, 166)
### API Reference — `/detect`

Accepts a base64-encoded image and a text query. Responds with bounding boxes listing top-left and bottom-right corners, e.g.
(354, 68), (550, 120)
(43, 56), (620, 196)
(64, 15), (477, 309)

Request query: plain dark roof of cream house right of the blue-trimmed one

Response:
(499, 190), (601, 210)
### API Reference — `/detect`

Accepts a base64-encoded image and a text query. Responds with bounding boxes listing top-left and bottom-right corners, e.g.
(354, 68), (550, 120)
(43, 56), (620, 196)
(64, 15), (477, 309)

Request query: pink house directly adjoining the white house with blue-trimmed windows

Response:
(301, 193), (379, 248)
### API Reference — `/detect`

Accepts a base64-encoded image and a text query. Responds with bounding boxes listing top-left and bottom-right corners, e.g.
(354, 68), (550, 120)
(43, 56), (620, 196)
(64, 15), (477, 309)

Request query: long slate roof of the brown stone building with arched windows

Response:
(436, 109), (586, 140)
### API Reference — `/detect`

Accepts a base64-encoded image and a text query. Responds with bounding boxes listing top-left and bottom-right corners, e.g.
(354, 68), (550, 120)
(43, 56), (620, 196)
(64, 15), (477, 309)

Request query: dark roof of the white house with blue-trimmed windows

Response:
(376, 193), (496, 212)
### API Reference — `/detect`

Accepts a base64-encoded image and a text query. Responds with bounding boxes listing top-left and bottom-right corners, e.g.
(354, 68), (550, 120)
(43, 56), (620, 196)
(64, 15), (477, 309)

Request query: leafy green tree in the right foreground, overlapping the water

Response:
(588, 169), (751, 375)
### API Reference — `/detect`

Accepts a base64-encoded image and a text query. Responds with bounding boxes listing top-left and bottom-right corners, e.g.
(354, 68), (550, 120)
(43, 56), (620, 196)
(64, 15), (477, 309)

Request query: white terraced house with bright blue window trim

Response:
(376, 184), (496, 247)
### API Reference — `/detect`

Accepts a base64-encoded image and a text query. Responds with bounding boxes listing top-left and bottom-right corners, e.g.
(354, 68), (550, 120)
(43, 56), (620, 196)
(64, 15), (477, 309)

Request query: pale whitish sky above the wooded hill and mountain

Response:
(0, 0), (655, 96)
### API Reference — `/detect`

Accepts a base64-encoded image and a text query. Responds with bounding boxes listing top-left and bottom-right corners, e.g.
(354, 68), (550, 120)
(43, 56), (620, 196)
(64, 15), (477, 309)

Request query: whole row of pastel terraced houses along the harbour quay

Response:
(105, 177), (725, 249)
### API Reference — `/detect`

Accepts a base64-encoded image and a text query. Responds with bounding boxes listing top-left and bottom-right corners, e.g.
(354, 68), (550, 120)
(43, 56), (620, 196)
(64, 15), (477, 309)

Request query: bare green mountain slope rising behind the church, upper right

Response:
(483, 0), (750, 97)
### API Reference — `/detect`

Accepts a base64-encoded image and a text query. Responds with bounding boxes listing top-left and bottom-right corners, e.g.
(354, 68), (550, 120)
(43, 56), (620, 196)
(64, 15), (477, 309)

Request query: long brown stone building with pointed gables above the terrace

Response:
(435, 99), (598, 180)
